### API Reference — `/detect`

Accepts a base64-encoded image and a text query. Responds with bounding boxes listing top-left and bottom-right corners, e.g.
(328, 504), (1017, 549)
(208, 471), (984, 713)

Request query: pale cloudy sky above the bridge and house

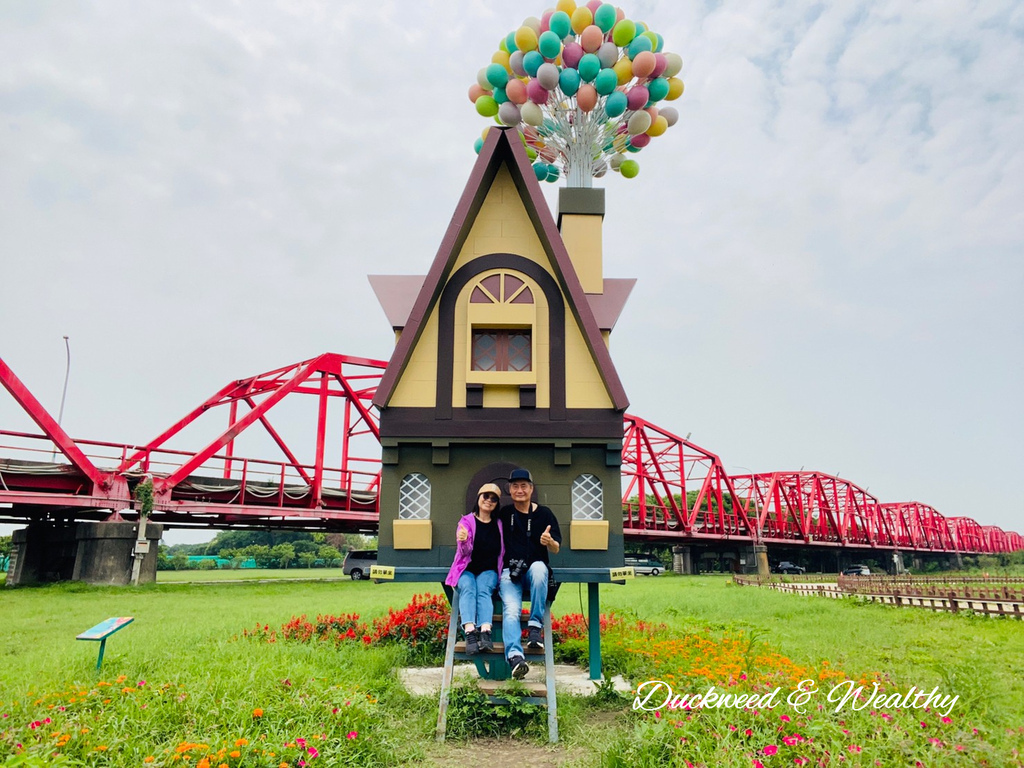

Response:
(0, 0), (1024, 544)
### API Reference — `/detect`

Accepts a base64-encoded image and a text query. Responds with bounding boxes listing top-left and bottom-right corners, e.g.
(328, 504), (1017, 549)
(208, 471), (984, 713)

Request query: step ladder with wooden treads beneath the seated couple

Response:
(437, 588), (558, 743)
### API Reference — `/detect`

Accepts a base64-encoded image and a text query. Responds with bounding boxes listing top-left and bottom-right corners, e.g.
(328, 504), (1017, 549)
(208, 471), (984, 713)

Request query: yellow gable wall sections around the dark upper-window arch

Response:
(389, 167), (612, 409)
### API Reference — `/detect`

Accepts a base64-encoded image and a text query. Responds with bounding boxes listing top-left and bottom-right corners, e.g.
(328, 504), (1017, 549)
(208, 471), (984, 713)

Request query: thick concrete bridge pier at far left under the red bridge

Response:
(7, 522), (164, 587)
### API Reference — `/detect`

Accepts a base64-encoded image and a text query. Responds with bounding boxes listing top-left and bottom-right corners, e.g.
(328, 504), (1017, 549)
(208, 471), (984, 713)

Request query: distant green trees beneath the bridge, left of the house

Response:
(157, 530), (377, 570)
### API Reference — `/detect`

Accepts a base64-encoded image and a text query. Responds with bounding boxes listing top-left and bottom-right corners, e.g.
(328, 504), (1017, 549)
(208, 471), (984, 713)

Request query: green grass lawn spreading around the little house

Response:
(0, 569), (1024, 768)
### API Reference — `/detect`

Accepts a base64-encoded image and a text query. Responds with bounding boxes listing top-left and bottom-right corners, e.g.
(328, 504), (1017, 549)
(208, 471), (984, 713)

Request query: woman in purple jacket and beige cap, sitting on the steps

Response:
(444, 482), (505, 654)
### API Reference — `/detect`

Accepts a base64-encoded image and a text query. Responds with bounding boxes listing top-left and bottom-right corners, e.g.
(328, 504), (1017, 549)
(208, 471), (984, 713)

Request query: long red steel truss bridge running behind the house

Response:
(0, 353), (1024, 554)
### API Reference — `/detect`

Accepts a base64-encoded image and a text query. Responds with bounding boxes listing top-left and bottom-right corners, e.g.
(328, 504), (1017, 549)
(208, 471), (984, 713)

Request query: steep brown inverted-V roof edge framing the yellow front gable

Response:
(374, 128), (629, 411)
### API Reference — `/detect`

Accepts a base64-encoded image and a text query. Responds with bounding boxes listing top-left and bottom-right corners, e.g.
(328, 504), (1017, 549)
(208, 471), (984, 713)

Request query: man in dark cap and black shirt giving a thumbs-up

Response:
(498, 469), (562, 680)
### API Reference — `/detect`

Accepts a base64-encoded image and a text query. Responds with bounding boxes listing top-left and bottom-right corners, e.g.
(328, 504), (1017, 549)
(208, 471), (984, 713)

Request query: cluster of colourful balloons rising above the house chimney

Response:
(469, 0), (683, 186)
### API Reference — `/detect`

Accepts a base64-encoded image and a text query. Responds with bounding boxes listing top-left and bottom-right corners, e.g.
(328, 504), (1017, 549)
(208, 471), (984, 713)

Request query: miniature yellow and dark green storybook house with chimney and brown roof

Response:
(370, 128), (635, 581)
